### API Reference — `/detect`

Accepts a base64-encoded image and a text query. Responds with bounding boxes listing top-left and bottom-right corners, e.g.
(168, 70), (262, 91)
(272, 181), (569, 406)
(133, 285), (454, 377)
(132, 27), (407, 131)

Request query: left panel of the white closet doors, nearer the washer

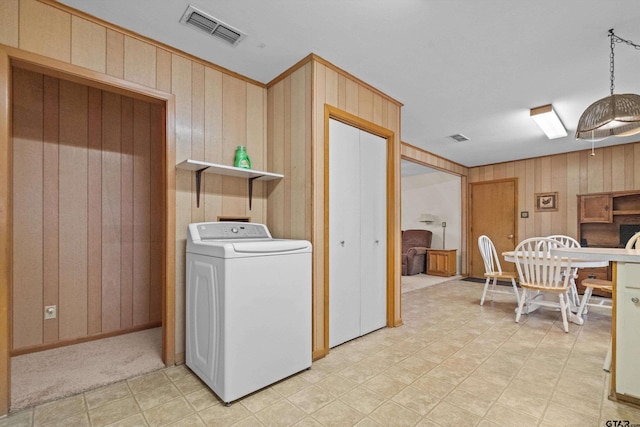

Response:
(329, 120), (360, 347)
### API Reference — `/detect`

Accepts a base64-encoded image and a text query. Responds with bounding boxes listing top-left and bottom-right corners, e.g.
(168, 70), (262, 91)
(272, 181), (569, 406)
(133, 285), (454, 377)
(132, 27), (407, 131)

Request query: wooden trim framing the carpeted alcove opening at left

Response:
(0, 45), (176, 417)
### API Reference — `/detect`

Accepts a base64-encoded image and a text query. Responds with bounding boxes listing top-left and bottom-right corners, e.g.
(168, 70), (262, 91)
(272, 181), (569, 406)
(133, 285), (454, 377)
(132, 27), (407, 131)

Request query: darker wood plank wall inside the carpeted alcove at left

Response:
(12, 68), (164, 354)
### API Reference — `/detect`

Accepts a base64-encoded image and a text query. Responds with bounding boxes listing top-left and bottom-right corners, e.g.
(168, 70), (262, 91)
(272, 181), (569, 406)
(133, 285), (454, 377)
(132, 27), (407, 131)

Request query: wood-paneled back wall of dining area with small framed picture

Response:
(469, 142), (640, 241)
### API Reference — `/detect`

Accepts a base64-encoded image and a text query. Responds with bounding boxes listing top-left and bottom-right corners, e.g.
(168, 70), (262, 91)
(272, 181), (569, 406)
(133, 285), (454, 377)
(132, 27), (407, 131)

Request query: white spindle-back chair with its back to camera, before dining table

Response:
(514, 237), (571, 332)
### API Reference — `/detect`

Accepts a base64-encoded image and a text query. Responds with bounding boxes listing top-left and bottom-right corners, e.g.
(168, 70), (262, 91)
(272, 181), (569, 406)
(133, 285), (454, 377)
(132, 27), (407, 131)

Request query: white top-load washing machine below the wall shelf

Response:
(186, 222), (311, 403)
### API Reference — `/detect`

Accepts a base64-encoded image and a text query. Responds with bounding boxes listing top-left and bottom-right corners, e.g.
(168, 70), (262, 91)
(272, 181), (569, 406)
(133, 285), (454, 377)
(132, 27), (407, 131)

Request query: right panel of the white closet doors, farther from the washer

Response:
(360, 131), (387, 335)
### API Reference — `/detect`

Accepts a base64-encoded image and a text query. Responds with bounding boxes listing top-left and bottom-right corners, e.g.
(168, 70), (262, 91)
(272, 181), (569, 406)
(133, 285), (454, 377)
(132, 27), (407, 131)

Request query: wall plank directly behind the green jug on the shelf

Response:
(221, 75), (251, 216)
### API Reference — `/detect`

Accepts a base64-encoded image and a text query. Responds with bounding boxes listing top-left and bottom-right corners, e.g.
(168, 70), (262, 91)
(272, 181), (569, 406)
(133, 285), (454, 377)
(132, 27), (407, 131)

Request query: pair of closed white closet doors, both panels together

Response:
(328, 120), (387, 347)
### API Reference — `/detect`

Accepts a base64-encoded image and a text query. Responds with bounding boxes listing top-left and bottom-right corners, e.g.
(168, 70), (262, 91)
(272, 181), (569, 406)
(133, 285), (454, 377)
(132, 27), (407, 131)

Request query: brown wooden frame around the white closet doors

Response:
(323, 104), (402, 352)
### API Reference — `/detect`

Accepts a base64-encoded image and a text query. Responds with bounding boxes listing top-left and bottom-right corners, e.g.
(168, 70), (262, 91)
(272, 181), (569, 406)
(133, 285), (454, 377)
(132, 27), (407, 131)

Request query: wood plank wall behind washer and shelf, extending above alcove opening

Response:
(0, 0), (267, 361)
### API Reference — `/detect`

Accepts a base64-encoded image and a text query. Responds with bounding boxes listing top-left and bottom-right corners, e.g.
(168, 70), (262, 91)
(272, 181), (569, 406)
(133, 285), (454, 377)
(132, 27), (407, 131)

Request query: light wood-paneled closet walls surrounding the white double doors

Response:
(267, 55), (402, 358)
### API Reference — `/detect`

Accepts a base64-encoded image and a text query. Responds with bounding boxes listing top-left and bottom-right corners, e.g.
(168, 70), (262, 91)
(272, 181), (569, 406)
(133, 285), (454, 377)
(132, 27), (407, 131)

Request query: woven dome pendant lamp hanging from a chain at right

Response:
(576, 29), (640, 143)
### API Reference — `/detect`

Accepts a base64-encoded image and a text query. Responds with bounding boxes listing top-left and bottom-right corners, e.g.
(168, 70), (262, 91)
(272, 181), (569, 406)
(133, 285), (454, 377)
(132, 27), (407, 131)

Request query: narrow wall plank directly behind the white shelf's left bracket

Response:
(191, 64), (206, 222)
